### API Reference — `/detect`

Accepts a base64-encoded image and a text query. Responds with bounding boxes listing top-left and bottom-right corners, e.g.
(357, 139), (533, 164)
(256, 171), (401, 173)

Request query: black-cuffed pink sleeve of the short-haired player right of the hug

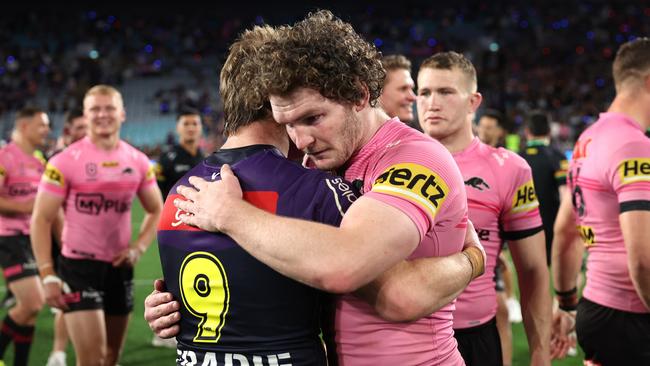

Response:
(499, 154), (543, 240)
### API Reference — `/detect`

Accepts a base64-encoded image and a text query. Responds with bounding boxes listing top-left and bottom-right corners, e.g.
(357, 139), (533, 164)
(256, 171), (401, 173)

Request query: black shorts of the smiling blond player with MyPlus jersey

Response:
(58, 256), (133, 315)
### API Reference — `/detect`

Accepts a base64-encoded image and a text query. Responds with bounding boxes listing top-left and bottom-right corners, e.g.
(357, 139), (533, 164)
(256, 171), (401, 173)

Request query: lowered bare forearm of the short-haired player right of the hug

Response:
(519, 266), (552, 365)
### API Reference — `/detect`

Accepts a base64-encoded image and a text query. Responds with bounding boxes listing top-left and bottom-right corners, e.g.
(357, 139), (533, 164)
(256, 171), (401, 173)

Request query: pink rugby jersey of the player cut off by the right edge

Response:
(567, 113), (650, 313)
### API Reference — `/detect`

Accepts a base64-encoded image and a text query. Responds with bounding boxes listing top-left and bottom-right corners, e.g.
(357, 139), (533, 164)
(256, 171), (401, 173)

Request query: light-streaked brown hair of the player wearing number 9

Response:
(219, 25), (285, 136)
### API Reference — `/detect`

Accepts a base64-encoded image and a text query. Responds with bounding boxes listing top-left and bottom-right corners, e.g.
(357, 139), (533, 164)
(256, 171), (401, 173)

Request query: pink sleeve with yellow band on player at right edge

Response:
(605, 139), (650, 213)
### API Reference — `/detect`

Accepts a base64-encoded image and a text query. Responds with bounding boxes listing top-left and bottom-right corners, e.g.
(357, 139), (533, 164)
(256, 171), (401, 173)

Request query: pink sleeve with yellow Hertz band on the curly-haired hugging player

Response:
(364, 142), (467, 238)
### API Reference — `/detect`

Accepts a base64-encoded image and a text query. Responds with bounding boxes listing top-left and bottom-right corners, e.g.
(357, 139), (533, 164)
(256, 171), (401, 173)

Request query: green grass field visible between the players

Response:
(0, 204), (582, 366)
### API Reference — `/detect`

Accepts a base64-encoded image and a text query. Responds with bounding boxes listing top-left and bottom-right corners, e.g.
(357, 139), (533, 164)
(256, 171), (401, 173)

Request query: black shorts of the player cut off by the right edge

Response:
(576, 298), (650, 366)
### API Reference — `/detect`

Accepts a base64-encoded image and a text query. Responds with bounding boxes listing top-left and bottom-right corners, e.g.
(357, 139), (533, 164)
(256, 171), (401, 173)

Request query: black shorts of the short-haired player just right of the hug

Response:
(454, 317), (503, 366)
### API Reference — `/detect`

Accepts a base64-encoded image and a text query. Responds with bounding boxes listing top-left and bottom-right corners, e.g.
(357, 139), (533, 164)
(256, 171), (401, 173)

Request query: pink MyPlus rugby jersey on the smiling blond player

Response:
(38, 137), (156, 262)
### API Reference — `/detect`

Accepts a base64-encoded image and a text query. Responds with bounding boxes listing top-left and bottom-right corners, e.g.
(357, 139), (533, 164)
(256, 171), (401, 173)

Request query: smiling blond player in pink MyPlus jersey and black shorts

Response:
(31, 85), (162, 365)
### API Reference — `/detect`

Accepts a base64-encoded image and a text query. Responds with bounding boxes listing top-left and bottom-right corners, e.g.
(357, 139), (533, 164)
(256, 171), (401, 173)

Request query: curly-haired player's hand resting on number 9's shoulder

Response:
(174, 164), (243, 232)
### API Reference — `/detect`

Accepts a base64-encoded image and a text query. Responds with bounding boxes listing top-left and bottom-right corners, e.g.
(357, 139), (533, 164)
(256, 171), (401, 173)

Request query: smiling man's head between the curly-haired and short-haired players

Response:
(379, 55), (415, 124)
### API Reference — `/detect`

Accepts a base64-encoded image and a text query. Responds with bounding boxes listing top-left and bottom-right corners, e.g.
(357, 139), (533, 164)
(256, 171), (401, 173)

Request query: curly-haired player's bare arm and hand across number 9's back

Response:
(174, 165), (420, 293)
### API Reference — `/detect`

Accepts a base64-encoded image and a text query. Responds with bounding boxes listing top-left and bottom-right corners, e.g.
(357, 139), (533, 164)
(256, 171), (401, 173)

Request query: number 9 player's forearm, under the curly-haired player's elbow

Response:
(356, 253), (472, 321)
